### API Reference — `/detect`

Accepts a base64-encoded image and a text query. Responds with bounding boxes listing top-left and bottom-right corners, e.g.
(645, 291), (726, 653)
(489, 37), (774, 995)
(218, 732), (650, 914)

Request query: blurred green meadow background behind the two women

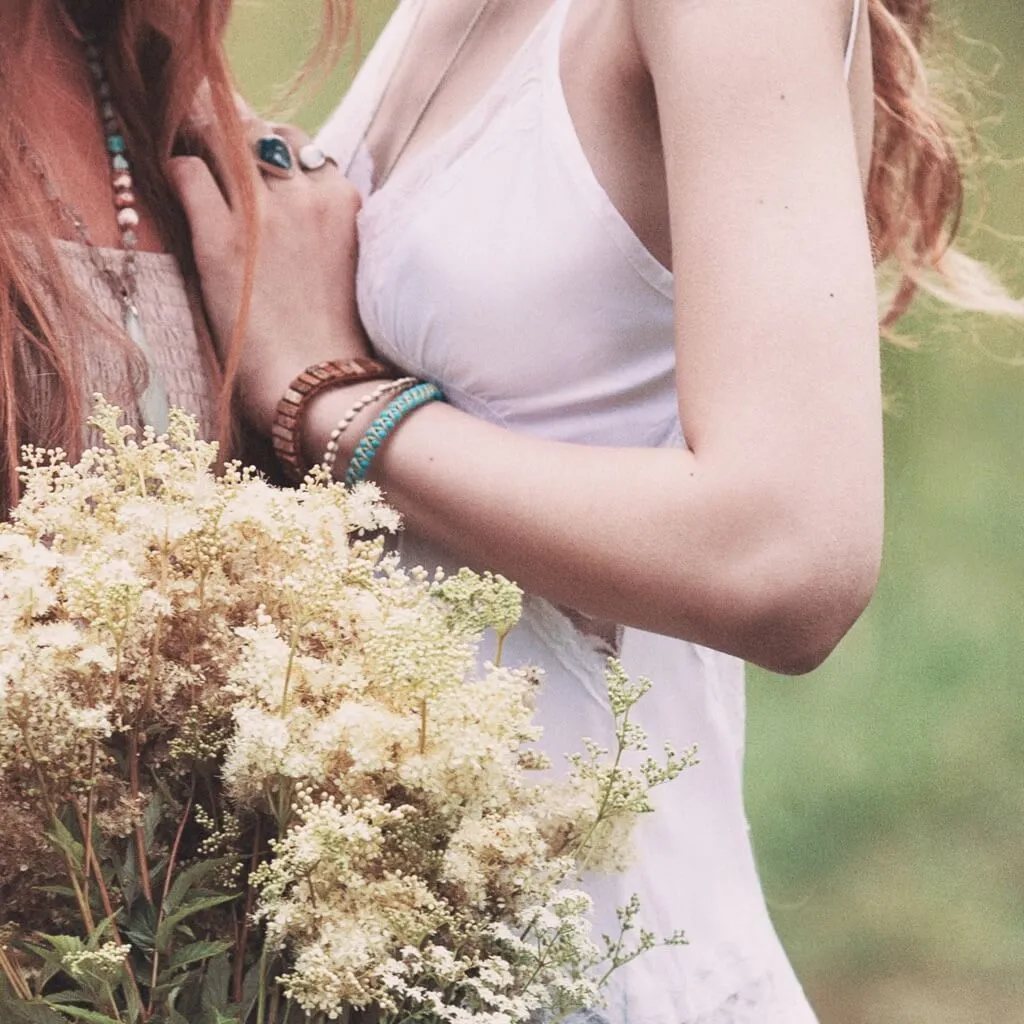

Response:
(232, 0), (1024, 1024)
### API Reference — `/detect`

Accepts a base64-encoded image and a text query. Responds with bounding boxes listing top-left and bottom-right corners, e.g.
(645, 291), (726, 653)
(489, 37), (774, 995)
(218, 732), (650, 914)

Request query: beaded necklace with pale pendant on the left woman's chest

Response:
(23, 23), (170, 433)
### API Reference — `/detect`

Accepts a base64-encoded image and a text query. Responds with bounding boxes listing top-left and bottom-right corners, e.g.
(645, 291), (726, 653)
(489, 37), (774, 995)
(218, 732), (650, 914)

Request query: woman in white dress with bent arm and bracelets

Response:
(174, 0), (1019, 1024)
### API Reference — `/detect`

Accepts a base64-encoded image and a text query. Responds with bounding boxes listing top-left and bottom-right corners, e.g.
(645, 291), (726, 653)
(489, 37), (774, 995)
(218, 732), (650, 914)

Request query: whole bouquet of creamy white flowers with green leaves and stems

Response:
(0, 400), (691, 1024)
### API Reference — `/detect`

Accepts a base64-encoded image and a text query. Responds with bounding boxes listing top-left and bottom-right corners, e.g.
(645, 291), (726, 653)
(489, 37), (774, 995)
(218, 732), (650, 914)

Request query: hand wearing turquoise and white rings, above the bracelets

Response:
(169, 121), (368, 434)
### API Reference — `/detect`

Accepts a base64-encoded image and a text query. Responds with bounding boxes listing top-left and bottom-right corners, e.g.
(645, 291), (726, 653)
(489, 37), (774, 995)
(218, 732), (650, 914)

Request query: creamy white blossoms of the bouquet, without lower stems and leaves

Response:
(0, 400), (688, 1024)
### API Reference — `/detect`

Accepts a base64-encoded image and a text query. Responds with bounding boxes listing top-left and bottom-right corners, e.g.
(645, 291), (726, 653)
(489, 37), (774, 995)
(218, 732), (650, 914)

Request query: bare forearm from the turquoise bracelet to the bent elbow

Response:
(305, 389), (877, 672)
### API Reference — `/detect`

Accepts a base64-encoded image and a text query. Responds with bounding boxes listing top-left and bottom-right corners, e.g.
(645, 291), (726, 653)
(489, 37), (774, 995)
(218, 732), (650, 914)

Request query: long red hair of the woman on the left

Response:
(0, 0), (268, 514)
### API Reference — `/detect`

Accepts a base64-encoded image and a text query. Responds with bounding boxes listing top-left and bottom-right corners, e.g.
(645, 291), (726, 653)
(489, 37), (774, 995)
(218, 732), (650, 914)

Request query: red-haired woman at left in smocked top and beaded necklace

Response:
(0, 0), (270, 516)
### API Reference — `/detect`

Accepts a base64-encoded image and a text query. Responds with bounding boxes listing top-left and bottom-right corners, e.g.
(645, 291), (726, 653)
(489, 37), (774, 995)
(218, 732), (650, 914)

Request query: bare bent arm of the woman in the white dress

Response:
(172, 0), (882, 672)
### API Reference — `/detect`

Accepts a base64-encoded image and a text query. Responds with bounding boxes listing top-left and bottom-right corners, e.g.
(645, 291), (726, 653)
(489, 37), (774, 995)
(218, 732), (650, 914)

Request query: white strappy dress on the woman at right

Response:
(319, 0), (856, 1024)
